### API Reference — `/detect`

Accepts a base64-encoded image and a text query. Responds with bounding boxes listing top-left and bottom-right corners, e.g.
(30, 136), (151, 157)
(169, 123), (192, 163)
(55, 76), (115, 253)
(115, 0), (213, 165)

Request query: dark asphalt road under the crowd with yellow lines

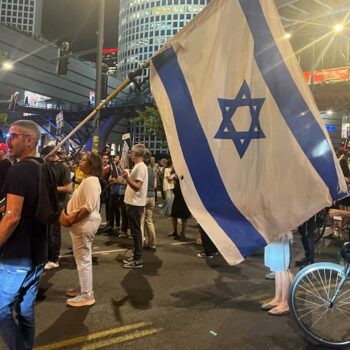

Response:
(0, 208), (339, 350)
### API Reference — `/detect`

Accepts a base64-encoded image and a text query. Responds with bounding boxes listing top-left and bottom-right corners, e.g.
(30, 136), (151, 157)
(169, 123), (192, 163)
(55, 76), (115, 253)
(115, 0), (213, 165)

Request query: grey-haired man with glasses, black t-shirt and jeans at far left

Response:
(0, 120), (47, 349)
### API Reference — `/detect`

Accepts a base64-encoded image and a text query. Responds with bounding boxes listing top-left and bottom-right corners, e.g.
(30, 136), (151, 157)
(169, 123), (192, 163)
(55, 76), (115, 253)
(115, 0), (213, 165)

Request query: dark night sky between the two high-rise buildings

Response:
(41, 0), (119, 60)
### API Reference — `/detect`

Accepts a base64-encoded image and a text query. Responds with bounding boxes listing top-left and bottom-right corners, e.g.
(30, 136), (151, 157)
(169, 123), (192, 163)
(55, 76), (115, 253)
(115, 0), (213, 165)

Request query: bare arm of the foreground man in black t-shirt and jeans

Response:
(0, 194), (24, 247)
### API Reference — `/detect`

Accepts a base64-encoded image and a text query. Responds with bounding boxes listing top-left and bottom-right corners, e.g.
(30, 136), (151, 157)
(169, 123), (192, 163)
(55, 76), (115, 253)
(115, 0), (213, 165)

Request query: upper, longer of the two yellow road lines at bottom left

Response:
(35, 322), (152, 350)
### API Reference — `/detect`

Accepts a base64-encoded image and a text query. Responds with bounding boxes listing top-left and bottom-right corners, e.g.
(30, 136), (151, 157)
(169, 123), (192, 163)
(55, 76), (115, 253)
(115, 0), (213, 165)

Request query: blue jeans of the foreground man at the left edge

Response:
(0, 262), (43, 350)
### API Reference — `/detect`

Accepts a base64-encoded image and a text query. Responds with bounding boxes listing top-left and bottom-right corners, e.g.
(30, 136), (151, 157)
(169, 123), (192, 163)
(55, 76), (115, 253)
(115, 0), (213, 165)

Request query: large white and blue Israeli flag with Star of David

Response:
(151, 0), (347, 264)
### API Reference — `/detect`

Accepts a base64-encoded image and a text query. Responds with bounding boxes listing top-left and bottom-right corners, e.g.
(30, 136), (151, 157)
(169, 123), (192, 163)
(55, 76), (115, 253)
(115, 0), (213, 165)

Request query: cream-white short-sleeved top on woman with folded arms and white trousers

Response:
(67, 176), (101, 216)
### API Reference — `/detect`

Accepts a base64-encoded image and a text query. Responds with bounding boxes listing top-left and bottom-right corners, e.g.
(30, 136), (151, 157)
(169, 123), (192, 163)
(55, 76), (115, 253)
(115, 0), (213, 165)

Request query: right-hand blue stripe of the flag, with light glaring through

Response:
(239, 0), (346, 200)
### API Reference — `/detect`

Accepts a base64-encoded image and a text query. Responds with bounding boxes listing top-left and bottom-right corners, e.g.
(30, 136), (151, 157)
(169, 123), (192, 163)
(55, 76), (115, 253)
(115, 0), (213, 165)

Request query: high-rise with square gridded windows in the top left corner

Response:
(0, 0), (42, 35)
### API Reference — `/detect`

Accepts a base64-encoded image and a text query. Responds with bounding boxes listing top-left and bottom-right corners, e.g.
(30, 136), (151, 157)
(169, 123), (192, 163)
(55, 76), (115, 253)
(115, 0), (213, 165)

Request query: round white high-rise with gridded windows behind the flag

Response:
(118, 0), (210, 79)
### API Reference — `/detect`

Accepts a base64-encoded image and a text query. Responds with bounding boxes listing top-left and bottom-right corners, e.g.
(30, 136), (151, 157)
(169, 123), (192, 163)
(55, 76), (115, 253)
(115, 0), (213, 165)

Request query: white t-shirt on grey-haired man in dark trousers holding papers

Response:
(124, 162), (148, 207)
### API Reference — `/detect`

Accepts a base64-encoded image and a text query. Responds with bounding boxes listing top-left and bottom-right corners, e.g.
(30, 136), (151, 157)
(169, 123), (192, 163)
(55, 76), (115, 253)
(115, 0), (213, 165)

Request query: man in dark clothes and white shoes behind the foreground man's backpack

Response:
(40, 146), (73, 270)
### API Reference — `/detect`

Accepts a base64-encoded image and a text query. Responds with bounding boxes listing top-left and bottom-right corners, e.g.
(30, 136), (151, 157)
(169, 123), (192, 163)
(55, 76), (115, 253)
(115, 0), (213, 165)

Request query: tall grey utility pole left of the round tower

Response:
(92, 0), (105, 153)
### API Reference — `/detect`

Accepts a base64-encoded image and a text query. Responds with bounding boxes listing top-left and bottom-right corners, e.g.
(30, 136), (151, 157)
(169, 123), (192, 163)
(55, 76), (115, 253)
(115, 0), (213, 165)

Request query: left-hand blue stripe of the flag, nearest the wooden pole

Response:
(152, 48), (266, 256)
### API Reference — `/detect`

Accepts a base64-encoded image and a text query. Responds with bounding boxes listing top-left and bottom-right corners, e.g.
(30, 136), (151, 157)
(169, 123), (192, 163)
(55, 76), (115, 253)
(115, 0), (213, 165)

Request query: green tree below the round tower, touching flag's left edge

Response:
(130, 106), (167, 146)
